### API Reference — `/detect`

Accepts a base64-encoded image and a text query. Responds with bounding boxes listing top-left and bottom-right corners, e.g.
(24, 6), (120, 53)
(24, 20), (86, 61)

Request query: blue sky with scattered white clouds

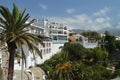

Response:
(0, 0), (120, 30)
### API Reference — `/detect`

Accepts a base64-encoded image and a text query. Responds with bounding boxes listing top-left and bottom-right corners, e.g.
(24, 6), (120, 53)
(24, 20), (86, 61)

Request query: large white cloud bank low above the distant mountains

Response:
(44, 8), (111, 31)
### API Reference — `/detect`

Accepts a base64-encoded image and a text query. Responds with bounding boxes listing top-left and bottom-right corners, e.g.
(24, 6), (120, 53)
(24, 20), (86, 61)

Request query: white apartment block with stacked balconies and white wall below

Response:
(43, 20), (68, 54)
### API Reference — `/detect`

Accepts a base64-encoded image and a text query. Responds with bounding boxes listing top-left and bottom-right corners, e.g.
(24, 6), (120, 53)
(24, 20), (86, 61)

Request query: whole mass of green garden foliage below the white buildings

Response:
(41, 43), (112, 80)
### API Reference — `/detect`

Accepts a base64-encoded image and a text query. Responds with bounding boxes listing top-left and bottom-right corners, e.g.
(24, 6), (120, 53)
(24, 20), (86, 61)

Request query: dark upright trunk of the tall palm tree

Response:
(8, 43), (15, 80)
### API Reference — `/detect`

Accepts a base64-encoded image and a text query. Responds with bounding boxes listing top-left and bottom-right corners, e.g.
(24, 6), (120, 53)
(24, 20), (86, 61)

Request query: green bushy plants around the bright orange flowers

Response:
(41, 51), (73, 80)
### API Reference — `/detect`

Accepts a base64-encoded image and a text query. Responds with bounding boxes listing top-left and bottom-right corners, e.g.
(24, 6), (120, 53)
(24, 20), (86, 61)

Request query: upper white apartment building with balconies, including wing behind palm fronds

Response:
(28, 19), (68, 54)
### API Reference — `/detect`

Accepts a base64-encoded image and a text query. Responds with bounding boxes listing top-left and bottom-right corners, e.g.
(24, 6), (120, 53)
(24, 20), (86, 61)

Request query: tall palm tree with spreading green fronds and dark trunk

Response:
(0, 4), (43, 80)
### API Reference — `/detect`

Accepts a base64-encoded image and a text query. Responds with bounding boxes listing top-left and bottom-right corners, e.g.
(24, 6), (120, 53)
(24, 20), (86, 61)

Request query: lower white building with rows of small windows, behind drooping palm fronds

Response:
(23, 35), (53, 68)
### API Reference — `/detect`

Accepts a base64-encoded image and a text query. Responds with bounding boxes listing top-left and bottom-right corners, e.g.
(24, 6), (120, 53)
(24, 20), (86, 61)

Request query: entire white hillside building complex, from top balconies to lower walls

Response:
(24, 19), (68, 68)
